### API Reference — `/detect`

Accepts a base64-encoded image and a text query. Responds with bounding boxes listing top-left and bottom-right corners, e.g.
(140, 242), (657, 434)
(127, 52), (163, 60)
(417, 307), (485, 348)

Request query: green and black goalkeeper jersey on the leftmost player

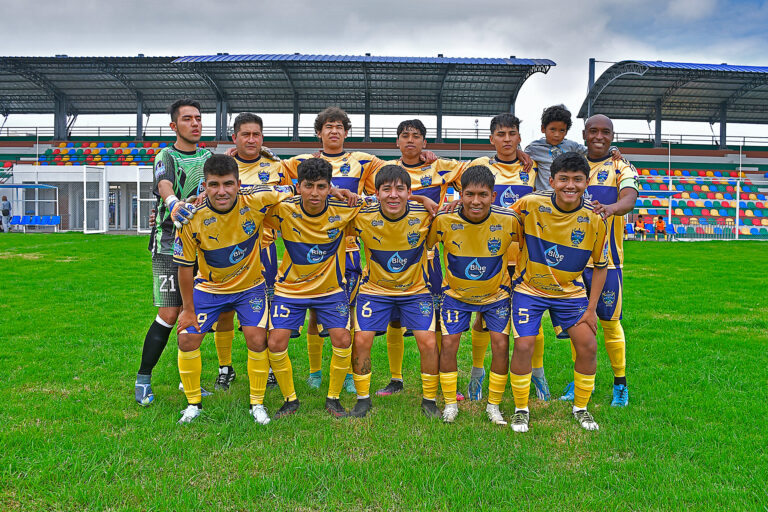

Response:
(149, 146), (213, 256)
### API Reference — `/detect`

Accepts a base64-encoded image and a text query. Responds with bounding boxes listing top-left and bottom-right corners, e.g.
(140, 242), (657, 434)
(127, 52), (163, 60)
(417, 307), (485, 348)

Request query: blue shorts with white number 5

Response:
(512, 292), (589, 338)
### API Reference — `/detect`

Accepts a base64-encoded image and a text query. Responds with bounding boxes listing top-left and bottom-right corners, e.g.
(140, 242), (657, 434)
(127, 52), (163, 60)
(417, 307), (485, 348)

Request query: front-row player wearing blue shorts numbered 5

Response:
(509, 152), (607, 432)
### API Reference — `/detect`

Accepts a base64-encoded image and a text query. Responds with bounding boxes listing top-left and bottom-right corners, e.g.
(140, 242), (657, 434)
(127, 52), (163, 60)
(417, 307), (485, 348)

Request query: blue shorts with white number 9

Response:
(184, 283), (268, 334)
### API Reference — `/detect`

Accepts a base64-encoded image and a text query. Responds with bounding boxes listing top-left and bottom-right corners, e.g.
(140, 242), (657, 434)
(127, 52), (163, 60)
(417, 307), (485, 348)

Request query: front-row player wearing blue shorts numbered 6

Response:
(351, 165), (440, 417)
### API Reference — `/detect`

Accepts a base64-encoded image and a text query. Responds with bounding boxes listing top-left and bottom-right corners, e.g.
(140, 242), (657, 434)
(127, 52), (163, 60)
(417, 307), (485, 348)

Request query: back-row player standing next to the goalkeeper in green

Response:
(208, 112), (292, 390)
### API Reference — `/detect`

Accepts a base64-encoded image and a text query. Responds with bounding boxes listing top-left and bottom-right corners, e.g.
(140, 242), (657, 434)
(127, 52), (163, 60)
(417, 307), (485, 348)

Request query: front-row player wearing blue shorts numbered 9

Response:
(173, 155), (293, 424)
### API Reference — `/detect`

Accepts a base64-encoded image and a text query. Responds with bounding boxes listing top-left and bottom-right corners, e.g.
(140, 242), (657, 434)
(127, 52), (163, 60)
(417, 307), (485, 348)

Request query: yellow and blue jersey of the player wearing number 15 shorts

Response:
(266, 196), (363, 298)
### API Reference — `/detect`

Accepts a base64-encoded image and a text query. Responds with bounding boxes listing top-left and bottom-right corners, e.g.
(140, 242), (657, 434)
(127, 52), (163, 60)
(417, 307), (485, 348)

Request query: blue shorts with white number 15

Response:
(270, 292), (349, 331)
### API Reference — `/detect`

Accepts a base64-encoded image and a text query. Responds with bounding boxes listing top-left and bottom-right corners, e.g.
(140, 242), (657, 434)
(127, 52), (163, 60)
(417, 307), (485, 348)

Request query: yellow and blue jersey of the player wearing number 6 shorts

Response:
(352, 201), (432, 296)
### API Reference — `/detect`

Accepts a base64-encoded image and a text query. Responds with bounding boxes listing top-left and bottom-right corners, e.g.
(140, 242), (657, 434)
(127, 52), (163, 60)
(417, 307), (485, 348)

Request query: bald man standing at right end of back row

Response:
(561, 114), (638, 407)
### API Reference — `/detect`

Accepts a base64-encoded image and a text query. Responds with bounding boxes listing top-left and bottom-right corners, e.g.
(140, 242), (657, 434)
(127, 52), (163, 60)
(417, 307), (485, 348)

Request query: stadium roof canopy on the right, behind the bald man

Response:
(579, 59), (768, 145)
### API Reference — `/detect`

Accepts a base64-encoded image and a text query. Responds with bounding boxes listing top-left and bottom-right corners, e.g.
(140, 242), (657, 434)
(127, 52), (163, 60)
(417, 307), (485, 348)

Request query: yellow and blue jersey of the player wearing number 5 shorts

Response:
(512, 192), (608, 299)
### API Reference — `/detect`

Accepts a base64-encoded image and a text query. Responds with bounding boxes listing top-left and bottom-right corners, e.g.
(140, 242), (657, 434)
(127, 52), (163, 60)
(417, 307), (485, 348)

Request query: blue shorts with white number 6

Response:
(355, 293), (435, 331)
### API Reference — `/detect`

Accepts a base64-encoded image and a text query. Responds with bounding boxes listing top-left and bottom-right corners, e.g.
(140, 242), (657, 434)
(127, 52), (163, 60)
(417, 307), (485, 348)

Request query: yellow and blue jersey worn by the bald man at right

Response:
(584, 153), (639, 268)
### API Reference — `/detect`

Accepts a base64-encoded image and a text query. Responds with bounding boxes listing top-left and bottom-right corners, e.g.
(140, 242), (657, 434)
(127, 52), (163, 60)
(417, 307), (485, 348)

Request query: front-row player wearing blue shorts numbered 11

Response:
(427, 165), (530, 425)
